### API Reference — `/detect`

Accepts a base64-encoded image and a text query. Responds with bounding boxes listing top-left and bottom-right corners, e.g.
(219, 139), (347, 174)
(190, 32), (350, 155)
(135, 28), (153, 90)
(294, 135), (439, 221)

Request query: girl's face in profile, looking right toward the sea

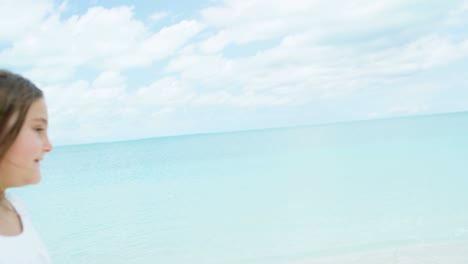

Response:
(0, 99), (52, 189)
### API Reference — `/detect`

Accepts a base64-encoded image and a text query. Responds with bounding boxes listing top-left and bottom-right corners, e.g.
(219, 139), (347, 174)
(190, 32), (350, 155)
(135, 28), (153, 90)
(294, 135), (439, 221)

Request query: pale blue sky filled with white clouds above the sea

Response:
(0, 0), (468, 145)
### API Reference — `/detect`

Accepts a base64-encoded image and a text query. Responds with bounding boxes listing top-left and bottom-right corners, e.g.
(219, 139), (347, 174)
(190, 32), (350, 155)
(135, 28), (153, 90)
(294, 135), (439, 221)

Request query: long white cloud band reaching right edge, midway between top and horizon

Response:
(166, 19), (468, 110)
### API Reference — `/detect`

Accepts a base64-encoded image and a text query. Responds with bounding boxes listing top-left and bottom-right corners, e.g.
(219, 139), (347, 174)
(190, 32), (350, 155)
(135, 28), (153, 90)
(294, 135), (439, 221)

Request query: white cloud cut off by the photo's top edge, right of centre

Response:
(197, 0), (416, 52)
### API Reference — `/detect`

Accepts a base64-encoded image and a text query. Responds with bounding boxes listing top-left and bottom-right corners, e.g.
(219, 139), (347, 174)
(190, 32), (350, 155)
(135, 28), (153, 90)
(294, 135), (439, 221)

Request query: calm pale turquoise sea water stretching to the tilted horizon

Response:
(14, 113), (468, 264)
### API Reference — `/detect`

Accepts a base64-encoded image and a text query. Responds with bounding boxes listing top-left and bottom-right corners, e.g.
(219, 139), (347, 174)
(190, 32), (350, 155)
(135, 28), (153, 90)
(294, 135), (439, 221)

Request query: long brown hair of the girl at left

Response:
(0, 69), (43, 160)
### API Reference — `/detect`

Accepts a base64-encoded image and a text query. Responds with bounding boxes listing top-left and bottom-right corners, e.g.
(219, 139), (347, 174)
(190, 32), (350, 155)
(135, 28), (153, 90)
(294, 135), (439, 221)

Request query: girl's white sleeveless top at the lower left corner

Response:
(0, 193), (51, 264)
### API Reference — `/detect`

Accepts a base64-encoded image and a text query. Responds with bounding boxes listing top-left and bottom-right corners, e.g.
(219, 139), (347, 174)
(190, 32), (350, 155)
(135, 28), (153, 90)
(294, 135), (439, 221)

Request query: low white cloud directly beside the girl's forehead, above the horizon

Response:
(42, 71), (172, 144)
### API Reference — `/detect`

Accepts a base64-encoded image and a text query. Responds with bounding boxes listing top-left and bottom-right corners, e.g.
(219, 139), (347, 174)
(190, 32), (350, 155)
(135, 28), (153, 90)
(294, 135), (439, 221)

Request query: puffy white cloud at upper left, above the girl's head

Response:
(0, 7), (147, 67)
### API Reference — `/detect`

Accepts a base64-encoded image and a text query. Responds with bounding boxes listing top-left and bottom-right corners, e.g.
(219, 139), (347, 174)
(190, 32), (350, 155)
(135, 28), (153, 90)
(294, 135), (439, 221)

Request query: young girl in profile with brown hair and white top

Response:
(0, 69), (52, 264)
